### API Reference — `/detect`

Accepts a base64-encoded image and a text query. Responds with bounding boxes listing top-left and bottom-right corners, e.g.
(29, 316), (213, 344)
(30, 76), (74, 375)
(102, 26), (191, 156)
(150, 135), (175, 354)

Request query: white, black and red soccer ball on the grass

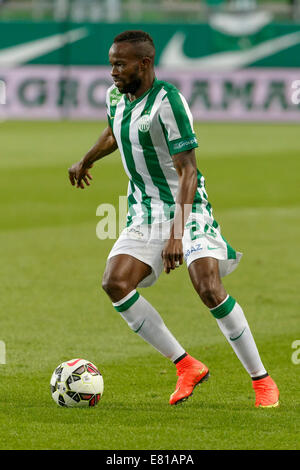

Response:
(50, 359), (104, 408)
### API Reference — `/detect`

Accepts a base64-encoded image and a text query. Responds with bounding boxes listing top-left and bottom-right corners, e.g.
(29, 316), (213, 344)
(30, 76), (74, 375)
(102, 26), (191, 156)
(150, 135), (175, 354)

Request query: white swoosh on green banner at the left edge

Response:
(0, 28), (89, 67)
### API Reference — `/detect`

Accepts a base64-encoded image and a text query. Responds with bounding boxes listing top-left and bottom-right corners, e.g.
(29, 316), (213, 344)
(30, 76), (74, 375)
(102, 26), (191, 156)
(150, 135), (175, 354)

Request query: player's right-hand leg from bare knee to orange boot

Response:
(189, 257), (278, 406)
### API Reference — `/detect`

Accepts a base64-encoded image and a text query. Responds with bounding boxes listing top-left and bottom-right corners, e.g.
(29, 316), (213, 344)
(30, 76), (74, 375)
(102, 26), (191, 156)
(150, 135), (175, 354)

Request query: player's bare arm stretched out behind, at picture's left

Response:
(68, 126), (118, 189)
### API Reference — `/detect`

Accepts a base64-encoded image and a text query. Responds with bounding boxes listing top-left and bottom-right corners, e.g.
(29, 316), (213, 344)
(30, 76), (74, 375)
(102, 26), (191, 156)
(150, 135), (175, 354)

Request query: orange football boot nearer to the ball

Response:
(169, 354), (209, 405)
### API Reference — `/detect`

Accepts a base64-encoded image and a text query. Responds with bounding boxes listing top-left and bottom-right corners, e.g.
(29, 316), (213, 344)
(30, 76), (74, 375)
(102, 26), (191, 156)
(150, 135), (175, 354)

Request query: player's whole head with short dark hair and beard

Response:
(109, 30), (155, 93)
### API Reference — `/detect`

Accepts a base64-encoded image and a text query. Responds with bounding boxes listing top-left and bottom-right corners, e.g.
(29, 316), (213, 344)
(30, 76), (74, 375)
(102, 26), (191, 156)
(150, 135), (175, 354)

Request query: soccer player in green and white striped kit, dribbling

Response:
(69, 31), (279, 407)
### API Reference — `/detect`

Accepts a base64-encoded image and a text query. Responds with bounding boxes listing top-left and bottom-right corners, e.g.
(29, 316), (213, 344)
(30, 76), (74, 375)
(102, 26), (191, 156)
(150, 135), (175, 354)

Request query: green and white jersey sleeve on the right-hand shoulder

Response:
(159, 89), (198, 155)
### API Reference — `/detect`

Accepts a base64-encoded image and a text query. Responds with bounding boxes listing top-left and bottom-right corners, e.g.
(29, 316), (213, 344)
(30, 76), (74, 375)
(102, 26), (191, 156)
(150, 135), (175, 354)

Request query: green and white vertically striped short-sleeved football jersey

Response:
(106, 79), (211, 226)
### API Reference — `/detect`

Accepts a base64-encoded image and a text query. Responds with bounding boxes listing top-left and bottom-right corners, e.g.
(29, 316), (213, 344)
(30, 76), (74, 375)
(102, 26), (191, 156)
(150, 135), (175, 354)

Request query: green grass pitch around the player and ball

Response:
(0, 122), (300, 450)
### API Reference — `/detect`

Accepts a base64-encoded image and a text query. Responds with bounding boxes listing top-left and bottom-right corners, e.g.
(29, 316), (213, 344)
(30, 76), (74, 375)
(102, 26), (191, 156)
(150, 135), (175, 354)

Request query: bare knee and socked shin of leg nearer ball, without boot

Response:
(102, 254), (186, 363)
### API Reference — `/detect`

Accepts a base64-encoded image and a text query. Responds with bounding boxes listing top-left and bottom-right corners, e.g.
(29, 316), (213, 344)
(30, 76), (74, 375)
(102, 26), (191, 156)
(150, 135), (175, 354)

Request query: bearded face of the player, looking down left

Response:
(109, 42), (142, 94)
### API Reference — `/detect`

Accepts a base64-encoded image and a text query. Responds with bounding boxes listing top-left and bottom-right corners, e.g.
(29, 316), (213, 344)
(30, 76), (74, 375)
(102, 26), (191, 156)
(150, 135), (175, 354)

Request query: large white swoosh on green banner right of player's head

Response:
(159, 31), (300, 71)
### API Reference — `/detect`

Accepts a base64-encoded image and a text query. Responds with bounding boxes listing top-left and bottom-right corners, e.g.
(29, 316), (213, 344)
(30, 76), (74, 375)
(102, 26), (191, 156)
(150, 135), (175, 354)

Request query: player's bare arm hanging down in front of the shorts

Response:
(162, 148), (197, 274)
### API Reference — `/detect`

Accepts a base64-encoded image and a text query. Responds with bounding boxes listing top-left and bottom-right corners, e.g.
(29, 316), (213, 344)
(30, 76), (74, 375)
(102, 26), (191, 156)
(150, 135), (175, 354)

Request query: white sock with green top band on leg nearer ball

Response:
(113, 290), (185, 362)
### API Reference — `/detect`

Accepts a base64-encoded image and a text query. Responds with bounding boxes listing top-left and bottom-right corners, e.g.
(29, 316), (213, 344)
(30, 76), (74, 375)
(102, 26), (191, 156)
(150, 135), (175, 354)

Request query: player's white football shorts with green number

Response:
(108, 213), (242, 287)
